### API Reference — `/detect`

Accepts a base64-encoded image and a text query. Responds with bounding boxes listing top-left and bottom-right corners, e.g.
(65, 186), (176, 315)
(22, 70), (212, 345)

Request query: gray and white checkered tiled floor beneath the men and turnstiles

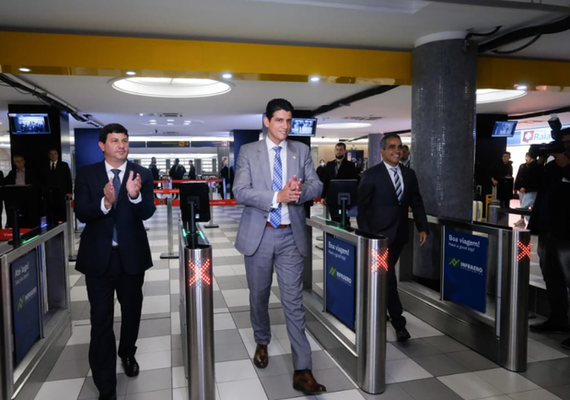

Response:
(32, 206), (570, 400)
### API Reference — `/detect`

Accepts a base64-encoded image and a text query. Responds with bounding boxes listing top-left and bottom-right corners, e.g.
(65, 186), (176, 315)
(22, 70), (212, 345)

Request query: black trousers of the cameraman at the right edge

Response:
(538, 232), (570, 325)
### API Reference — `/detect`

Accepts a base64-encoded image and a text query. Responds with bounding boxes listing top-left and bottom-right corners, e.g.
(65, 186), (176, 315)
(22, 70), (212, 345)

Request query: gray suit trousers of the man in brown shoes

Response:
(245, 227), (312, 370)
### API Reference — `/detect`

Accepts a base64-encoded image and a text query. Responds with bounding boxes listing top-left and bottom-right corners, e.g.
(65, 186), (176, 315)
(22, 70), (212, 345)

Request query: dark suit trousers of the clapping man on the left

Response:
(85, 250), (144, 395)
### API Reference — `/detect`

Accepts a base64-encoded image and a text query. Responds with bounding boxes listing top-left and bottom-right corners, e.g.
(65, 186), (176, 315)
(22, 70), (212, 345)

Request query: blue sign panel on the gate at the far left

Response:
(10, 250), (40, 365)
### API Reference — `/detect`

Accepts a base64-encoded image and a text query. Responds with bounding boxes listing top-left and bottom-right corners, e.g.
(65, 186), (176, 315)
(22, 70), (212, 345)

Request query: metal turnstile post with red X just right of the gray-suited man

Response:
(356, 232), (388, 394)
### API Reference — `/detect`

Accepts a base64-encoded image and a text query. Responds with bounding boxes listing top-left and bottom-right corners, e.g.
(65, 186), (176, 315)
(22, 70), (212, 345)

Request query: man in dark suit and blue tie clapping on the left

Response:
(75, 124), (155, 400)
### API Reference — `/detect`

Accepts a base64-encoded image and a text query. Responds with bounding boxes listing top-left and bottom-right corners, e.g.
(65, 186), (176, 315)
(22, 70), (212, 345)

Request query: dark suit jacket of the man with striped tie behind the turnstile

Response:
(357, 162), (429, 245)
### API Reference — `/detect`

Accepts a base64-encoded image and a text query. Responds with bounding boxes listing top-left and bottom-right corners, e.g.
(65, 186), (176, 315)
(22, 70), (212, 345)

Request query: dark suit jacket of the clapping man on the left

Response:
(75, 161), (156, 276)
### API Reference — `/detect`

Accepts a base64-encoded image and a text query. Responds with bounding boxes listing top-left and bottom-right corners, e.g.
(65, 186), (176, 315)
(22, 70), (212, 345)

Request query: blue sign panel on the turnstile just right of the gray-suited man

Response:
(325, 234), (356, 330)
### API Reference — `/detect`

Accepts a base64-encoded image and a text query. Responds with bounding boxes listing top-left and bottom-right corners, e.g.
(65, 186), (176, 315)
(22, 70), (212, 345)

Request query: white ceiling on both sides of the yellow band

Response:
(0, 0), (570, 143)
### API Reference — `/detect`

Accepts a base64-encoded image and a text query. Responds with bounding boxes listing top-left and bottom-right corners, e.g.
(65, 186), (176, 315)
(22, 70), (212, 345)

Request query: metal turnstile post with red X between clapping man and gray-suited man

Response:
(179, 228), (216, 400)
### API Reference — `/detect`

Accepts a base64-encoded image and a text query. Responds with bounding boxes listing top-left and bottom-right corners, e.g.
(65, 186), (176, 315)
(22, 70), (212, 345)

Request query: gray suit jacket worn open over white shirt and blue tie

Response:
(234, 139), (323, 256)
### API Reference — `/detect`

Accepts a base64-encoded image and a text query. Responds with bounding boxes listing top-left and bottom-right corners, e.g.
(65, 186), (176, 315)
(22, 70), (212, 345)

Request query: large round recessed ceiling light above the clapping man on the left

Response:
(112, 78), (231, 99)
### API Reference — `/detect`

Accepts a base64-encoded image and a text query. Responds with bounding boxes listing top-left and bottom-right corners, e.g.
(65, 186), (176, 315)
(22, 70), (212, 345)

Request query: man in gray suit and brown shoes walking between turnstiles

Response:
(234, 99), (326, 394)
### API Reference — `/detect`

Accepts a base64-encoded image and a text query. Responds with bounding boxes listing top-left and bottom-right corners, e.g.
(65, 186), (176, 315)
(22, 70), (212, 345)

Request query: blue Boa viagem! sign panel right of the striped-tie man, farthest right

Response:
(443, 229), (489, 313)
